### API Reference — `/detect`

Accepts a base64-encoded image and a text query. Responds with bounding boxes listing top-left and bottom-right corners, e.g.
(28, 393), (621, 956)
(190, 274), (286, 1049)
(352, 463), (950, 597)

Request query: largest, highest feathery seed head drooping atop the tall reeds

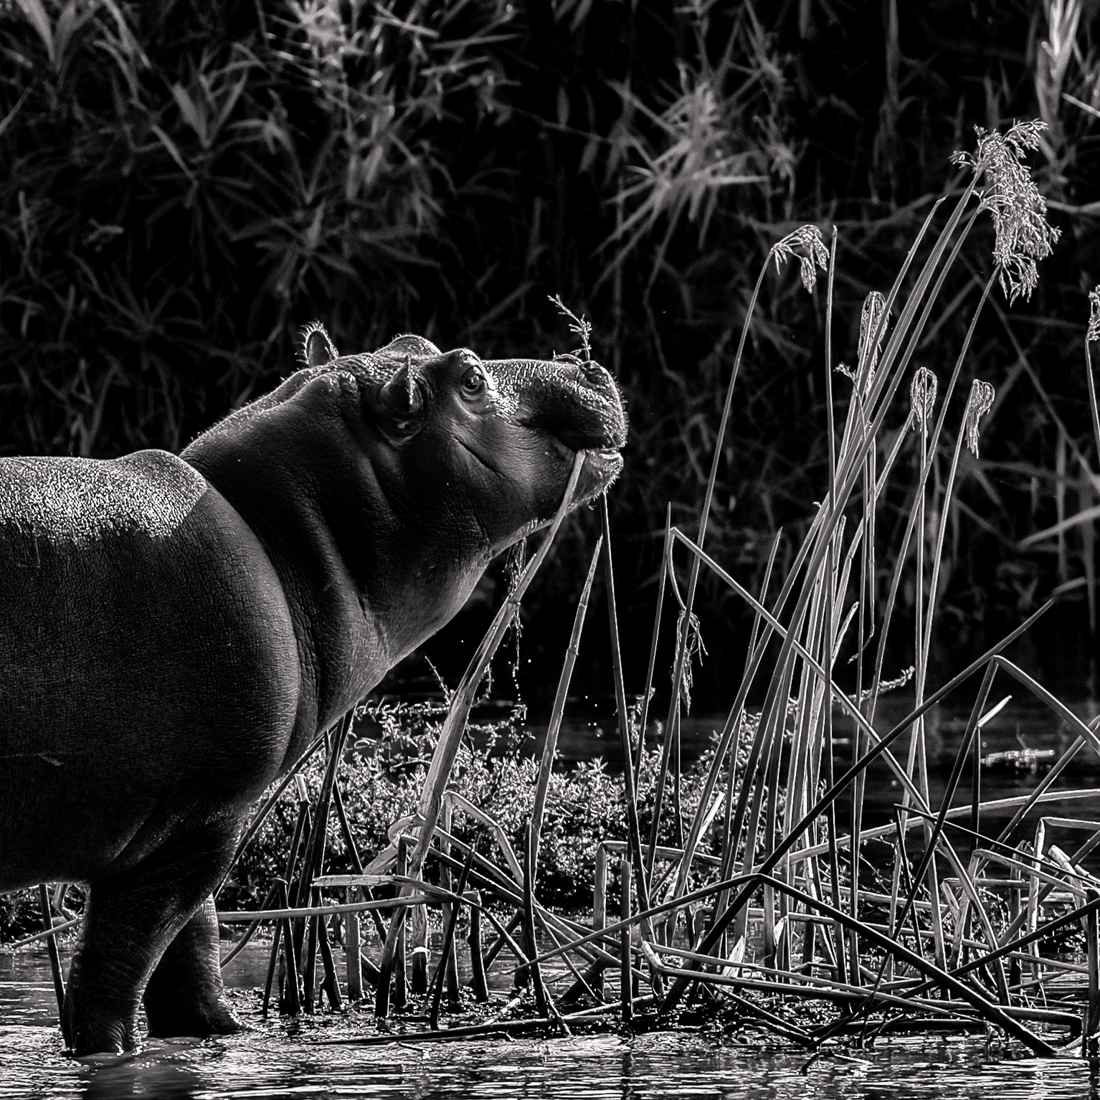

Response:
(952, 119), (1062, 305)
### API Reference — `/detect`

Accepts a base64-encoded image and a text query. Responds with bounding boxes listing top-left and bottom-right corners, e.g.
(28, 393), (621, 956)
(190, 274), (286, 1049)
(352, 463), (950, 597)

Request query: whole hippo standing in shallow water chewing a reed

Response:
(0, 327), (626, 1055)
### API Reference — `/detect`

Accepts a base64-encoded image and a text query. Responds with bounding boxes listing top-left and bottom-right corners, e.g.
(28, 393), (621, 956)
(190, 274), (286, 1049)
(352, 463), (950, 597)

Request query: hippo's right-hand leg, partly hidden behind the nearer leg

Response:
(145, 895), (241, 1038)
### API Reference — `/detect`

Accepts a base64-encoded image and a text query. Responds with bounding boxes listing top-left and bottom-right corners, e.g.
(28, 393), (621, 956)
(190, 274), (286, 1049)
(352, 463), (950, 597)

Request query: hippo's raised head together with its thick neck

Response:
(183, 326), (626, 677)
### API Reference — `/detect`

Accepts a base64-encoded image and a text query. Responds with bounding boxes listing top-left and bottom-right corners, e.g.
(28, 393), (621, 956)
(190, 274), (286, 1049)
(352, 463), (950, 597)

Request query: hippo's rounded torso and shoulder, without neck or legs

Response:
(0, 451), (299, 889)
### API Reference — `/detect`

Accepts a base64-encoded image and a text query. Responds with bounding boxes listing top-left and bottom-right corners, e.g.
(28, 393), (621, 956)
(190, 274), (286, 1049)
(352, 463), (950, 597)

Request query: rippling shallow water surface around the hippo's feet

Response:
(0, 945), (1100, 1100)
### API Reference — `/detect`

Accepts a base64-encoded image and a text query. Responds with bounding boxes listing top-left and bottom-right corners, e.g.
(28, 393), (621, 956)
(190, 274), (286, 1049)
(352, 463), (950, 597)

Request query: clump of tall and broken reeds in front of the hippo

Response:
(204, 123), (1100, 1054)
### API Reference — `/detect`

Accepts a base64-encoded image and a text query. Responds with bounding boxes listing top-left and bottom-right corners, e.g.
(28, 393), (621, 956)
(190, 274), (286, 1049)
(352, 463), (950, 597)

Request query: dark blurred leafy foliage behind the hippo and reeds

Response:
(0, 0), (1100, 699)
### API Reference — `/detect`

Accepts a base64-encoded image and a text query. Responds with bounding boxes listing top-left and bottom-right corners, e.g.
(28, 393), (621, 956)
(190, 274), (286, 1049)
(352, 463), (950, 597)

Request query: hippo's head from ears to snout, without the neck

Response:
(305, 327), (626, 553)
